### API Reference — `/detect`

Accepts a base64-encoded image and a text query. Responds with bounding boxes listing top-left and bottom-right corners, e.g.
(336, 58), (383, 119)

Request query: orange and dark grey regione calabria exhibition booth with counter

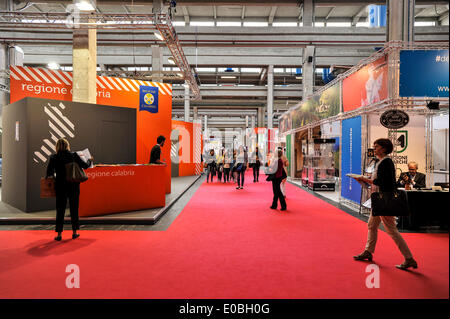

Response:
(2, 66), (176, 217)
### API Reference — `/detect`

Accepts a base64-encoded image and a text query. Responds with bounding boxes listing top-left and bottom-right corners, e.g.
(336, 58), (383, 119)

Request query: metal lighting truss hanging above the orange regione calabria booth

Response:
(0, 10), (201, 100)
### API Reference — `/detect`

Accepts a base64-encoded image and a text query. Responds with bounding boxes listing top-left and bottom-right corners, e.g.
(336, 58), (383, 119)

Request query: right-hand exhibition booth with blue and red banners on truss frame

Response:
(279, 42), (449, 230)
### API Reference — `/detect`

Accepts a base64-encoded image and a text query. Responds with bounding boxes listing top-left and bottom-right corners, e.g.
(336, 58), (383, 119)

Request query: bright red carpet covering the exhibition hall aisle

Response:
(0, 176), (449, 299)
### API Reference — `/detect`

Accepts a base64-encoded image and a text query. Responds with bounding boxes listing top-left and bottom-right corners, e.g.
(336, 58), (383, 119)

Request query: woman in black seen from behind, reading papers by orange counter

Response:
(46, 138), (93, 241)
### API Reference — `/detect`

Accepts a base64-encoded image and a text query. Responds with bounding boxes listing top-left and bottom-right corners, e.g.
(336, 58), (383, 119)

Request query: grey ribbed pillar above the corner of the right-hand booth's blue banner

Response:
(386, 0), (415, 42)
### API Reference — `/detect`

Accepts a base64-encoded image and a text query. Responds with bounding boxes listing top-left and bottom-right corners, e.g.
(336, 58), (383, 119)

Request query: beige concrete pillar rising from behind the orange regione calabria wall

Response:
(72, 0), (97, 104)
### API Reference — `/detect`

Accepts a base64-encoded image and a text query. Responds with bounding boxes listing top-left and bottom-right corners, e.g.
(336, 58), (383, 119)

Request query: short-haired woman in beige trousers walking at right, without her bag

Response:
(353, 138), (417, 270)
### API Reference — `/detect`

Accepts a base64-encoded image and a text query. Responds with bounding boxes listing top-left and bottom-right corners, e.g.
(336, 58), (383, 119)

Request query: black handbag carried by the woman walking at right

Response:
(370, 190), (409, 216)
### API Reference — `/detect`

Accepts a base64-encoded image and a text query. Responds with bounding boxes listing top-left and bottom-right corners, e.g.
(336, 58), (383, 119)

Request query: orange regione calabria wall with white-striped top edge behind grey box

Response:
(10, 66), (172, 193)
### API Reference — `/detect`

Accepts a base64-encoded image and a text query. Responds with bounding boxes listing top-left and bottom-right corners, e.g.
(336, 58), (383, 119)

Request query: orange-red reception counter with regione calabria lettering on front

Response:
(79, 165), (166, 217)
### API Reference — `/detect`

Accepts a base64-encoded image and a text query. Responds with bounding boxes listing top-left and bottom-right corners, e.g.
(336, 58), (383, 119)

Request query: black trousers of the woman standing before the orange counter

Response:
(55, 184), (80, 233)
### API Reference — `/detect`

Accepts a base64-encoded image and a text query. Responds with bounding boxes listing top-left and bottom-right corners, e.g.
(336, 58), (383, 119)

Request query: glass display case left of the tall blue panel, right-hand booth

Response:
(305, 138), (336, 191)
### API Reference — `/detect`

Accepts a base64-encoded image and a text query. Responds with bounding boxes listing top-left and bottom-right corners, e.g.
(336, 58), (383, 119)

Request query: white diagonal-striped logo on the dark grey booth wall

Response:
(33, 103), (75, 163)
